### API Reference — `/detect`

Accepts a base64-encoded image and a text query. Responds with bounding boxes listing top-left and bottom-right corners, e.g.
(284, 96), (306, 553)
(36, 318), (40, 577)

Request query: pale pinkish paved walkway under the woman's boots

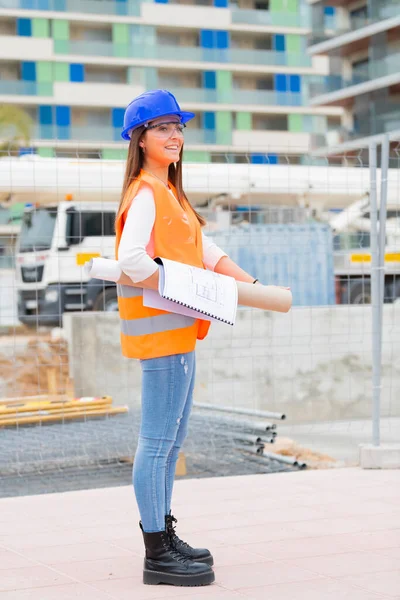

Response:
(0, 468), (400, 600)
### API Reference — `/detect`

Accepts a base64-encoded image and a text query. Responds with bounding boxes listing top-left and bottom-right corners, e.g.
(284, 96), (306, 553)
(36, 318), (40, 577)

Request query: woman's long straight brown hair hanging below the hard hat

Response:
(117, 125), (206, 226)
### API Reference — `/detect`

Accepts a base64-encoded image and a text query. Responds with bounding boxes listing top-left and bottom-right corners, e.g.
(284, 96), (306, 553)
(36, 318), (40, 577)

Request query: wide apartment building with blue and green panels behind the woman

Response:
(0, 0), (343, 164)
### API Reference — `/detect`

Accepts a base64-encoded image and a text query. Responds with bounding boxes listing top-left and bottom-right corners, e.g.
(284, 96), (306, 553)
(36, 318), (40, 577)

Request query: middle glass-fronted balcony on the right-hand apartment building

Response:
(309, 52), (400, 103)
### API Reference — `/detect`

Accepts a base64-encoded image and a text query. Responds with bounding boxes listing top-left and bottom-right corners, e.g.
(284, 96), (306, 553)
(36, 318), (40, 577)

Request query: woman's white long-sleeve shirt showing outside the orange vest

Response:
(118, 186), (227, 283)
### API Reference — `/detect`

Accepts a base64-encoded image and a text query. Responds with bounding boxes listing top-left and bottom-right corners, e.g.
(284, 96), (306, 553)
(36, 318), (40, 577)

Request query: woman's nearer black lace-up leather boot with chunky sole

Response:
(139, 522), (215, 586)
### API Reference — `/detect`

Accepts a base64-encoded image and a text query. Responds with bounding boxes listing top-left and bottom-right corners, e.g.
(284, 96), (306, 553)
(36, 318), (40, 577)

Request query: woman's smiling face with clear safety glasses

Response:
(139, 115), (183, 167)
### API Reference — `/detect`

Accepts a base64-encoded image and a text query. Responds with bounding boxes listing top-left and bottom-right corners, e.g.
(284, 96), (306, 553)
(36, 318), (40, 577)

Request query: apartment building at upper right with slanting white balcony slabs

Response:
(309, 0), (400, 156)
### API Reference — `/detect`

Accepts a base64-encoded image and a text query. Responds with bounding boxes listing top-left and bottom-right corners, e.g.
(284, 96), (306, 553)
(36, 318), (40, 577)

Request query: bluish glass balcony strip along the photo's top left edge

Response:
(0, 0), (142, 17)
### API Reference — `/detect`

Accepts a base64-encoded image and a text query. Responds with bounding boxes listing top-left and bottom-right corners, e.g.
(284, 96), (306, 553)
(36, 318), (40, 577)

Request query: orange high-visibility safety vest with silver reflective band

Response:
(115, 170), (210, 359)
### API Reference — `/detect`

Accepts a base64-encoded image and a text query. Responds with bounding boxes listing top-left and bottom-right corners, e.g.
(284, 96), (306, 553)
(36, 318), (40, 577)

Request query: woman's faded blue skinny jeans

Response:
(133, 351), (196, 533)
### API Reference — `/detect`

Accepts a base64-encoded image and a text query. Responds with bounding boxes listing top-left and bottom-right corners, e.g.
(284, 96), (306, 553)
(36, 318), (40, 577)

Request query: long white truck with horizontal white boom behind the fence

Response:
(0, 158), (400, 325)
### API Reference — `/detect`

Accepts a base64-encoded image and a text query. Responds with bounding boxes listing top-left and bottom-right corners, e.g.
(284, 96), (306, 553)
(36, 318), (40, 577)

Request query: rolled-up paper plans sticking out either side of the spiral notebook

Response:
(85, 258), (292, 312)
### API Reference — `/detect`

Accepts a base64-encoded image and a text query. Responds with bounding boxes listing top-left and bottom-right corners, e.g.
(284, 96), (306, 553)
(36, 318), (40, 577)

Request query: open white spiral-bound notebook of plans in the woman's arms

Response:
(143, 258), (238, 325)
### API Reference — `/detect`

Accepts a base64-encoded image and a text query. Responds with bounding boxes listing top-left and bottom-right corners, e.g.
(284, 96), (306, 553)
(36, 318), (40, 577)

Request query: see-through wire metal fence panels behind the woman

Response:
(0, 146), (400, 495)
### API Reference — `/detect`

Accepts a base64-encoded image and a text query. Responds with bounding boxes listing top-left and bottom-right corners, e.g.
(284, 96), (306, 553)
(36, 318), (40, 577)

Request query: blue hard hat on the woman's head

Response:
(121, 90), (195, 140)
